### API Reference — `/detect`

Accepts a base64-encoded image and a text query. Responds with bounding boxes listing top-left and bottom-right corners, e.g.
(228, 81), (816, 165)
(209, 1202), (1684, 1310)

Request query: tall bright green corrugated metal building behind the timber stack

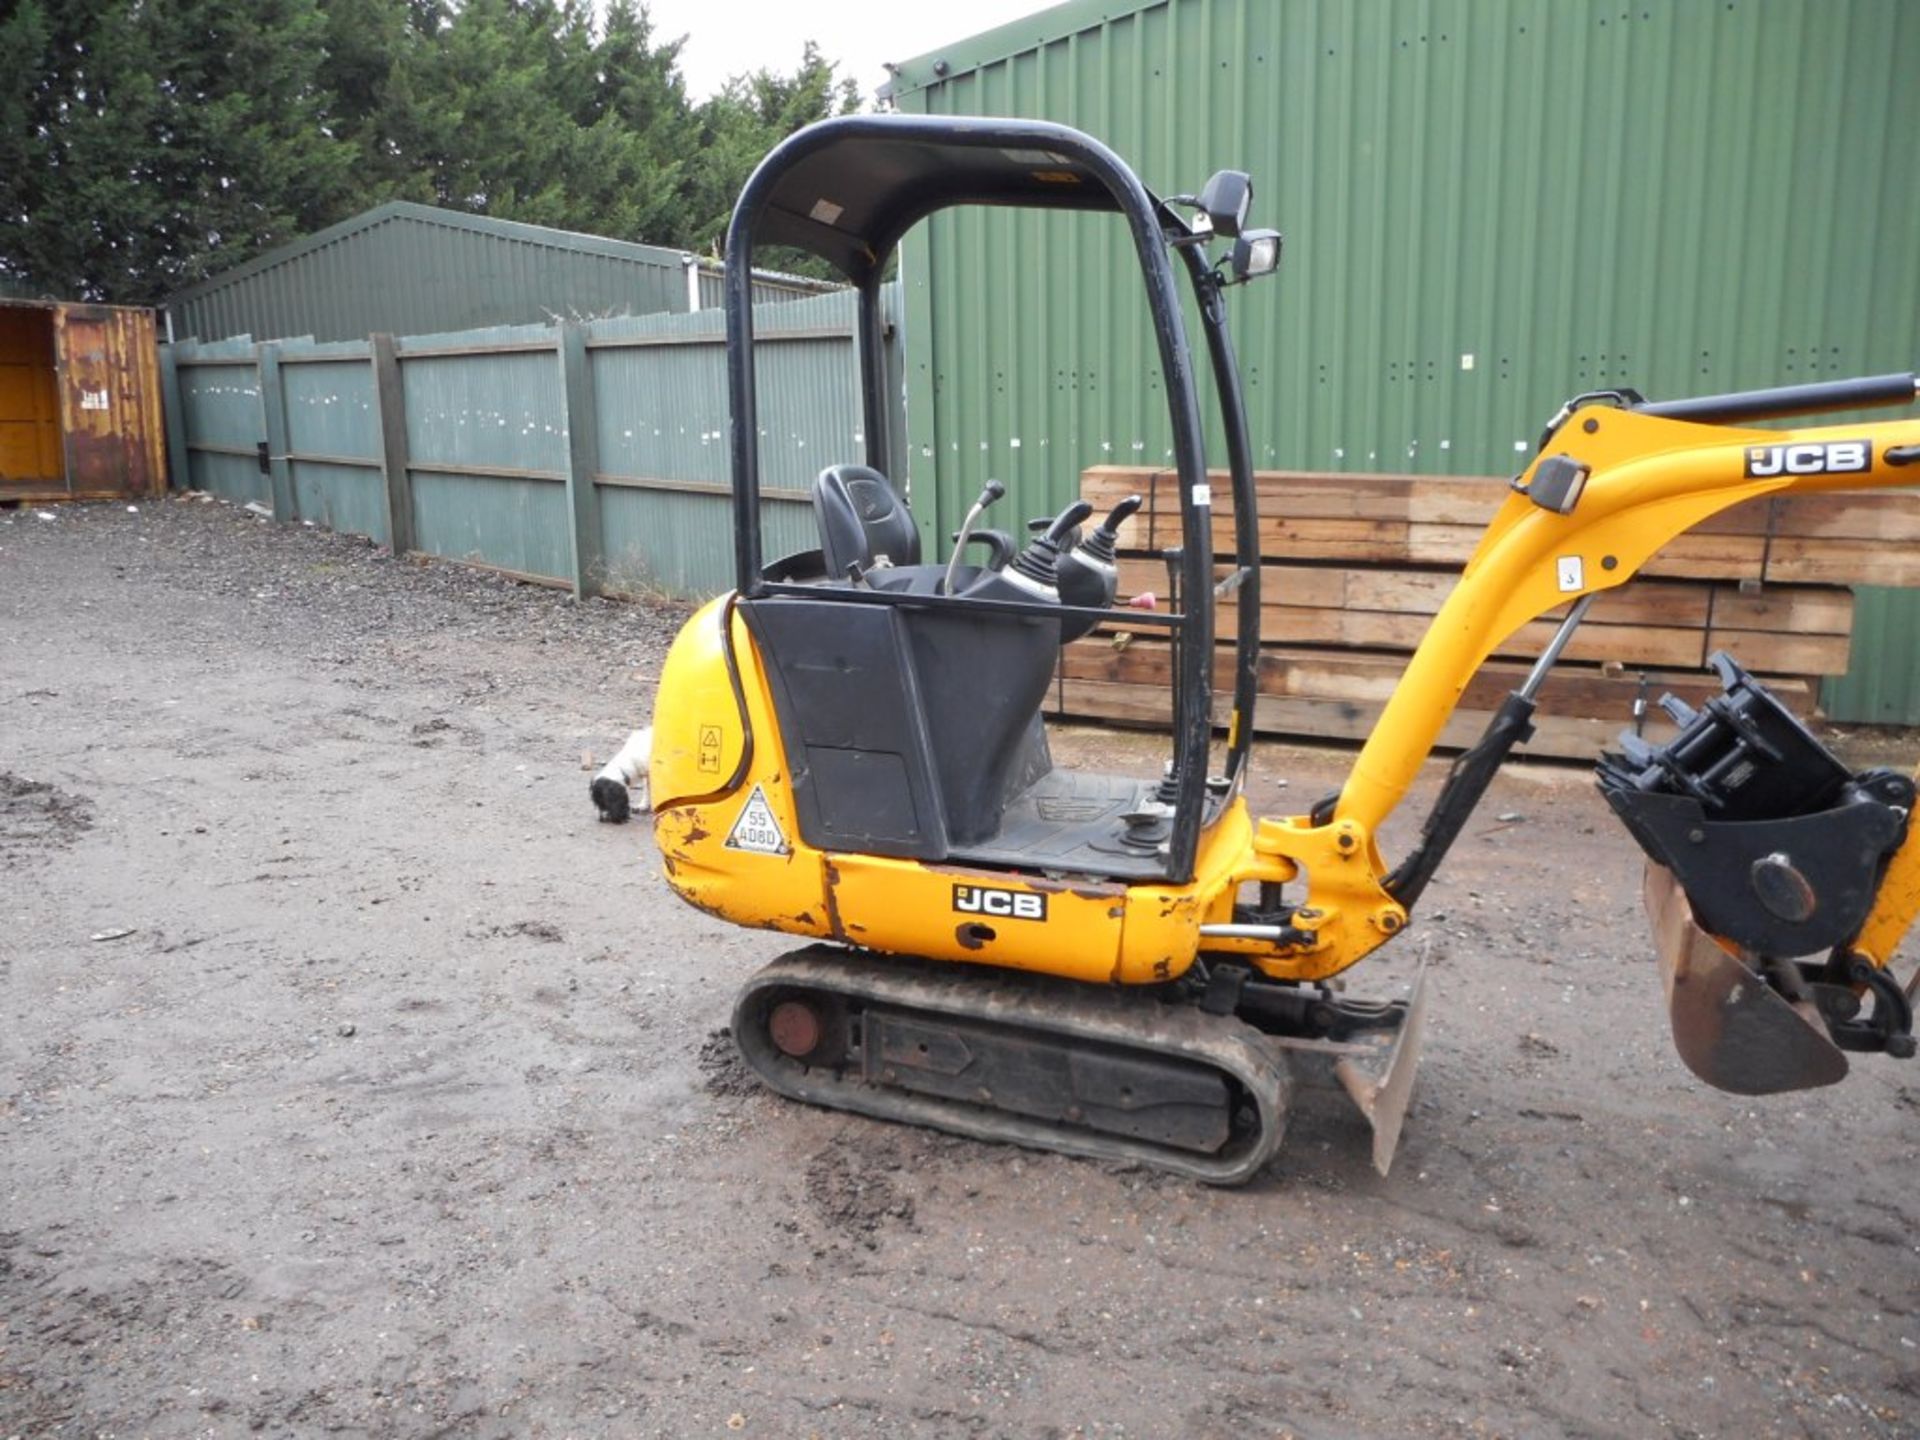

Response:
(893, 0), (1920, 724)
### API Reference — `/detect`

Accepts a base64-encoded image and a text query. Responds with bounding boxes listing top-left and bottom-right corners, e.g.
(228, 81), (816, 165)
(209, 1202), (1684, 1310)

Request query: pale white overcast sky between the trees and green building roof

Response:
(647, 0), (1054, 100)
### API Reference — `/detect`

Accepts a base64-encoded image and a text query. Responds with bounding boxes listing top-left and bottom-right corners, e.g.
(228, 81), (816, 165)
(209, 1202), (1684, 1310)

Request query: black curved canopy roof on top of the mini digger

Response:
(728, 115), (1156, 282)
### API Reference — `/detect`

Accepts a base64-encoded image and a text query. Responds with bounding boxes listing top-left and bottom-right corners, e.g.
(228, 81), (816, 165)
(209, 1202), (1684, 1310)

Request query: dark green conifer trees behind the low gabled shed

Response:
(0, 0), (860, 303)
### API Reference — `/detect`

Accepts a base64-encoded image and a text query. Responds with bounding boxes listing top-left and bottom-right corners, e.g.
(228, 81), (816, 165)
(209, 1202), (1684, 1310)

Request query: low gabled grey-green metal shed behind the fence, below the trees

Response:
(167, 202), (833, 340)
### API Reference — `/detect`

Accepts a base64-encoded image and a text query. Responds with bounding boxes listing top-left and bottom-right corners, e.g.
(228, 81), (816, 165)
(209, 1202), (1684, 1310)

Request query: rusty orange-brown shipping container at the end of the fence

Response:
(0, 300), (167, 503)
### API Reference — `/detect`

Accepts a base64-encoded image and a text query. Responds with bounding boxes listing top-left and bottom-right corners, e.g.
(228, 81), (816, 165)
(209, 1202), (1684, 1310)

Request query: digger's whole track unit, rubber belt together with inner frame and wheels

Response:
(733, 945), (1290, 1185)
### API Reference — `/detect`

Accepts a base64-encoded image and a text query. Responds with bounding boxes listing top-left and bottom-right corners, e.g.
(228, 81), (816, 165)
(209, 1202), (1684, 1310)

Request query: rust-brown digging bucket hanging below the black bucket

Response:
(1645, 862), (1847, 1094)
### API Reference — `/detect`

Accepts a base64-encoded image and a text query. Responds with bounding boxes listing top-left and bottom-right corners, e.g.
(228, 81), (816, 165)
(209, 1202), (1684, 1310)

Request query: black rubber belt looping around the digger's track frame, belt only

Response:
(733, 945), (1292, 1185)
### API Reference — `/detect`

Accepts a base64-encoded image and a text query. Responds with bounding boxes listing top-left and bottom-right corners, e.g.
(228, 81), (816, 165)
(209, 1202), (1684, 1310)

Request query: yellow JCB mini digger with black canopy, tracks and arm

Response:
(651, 115), (1920, 1183)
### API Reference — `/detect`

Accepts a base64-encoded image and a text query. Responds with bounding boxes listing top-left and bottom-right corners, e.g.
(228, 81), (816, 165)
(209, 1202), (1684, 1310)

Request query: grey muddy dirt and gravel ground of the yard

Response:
(11, 501), (1920, 1440)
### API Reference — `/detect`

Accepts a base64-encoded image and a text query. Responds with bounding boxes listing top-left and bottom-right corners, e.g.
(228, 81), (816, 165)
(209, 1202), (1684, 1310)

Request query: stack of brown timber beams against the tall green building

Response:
(1050, 467), (1920, 760)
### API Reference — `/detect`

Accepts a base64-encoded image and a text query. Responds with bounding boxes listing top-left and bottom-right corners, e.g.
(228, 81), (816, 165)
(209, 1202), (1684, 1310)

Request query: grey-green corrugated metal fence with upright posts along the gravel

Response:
(169, 290), (883, 595)
